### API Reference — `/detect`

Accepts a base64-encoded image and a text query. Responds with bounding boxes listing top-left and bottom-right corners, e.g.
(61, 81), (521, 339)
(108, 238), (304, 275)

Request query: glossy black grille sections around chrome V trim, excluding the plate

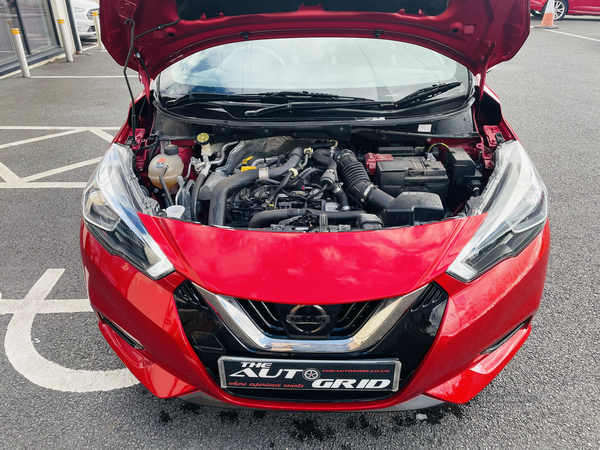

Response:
(174, 281), (448, 402)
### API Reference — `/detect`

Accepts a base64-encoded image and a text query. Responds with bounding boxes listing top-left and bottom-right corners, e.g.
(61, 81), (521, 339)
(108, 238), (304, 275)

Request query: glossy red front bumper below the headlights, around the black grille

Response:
(81, 220), (550, 411)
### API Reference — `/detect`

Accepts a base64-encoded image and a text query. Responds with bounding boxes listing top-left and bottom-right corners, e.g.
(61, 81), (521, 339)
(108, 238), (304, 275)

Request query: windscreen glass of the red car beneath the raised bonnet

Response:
(159, 38), (471, 101)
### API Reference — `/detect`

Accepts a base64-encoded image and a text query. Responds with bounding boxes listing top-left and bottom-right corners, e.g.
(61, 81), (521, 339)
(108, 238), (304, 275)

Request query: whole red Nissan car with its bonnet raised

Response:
(81, 0), (550, 411)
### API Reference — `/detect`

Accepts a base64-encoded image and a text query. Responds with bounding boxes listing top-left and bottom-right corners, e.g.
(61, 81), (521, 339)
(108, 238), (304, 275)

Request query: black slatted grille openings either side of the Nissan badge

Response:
(237, 298), (381, 338)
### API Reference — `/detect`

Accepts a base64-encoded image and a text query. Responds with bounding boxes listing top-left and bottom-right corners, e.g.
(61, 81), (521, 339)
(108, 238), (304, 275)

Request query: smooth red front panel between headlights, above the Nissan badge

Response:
(143, 216), (484, 304)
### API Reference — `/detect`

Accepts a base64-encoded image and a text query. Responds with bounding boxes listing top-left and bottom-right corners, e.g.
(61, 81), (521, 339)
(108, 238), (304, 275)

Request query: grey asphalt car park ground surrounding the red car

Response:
(0, 14), (600, 449)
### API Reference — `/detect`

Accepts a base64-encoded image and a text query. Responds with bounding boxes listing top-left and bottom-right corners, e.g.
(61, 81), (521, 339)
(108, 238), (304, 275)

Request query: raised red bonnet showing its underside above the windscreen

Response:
(100, 0), (529, 79)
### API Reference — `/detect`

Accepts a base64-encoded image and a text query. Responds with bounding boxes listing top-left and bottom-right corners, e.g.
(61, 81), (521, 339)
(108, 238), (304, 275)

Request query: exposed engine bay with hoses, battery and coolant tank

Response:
(132, 127), (503, 232)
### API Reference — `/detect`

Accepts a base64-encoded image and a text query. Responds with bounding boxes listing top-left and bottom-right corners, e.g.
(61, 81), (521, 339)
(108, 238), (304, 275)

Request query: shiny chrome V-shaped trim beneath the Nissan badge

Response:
(194, 284), (427, 353)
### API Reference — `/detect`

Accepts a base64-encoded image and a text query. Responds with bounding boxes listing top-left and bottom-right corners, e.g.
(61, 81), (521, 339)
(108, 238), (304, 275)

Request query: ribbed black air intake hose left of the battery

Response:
(338, 151), (394, 212)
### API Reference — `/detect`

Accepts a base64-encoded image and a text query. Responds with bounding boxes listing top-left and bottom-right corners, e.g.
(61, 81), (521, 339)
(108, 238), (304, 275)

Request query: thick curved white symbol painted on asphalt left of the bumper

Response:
(0, 269), (139, 392)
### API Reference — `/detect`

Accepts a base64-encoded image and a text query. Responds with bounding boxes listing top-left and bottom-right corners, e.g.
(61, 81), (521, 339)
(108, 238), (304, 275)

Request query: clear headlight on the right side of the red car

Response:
(448, 141), (548, 282)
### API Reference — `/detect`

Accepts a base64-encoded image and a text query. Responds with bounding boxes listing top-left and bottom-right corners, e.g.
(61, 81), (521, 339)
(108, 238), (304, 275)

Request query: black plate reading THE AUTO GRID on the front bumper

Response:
(219, 356), (400, 392)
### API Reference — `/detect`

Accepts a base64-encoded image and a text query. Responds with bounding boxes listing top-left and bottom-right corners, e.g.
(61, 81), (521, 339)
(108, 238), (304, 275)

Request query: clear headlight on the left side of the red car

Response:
(83, 144), (175, 280)
